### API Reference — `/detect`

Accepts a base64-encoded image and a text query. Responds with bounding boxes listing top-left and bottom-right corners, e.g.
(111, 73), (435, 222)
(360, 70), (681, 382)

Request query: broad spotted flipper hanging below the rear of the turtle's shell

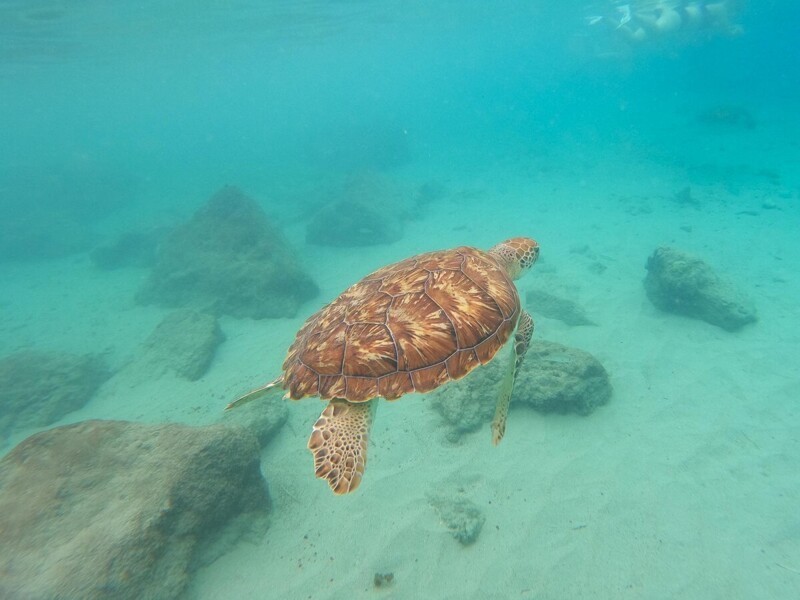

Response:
(308, 398), (376, 494)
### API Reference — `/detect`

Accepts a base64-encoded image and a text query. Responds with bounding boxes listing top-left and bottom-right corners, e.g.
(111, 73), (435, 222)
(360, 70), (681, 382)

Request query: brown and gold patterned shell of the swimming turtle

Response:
(283, 247), (520, 402)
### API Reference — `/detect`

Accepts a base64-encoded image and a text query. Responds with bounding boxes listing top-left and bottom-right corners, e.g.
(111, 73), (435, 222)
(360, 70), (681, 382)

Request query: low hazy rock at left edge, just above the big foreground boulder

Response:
(0, 351), (110, 437)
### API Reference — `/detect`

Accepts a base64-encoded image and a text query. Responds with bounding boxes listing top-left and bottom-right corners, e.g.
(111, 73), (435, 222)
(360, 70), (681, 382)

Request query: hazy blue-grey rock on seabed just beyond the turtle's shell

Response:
(306, 173), (411, 247)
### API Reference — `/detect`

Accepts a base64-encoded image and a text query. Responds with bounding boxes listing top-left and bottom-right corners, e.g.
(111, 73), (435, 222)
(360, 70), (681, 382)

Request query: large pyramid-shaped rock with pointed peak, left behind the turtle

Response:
(137, 186), (319, 319)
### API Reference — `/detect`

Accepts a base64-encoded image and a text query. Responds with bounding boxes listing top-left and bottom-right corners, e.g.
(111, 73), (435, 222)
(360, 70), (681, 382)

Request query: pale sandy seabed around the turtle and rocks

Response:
(0, 124), (800, 600)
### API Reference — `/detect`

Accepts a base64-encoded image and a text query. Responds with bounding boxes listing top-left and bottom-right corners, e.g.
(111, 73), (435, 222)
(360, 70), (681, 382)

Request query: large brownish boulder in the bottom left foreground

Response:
(0, 421), (269, 600)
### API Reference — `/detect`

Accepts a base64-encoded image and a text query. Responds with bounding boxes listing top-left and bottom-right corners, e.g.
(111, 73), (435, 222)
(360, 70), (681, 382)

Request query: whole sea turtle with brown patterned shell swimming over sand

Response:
(228, 237), (539, 494)
